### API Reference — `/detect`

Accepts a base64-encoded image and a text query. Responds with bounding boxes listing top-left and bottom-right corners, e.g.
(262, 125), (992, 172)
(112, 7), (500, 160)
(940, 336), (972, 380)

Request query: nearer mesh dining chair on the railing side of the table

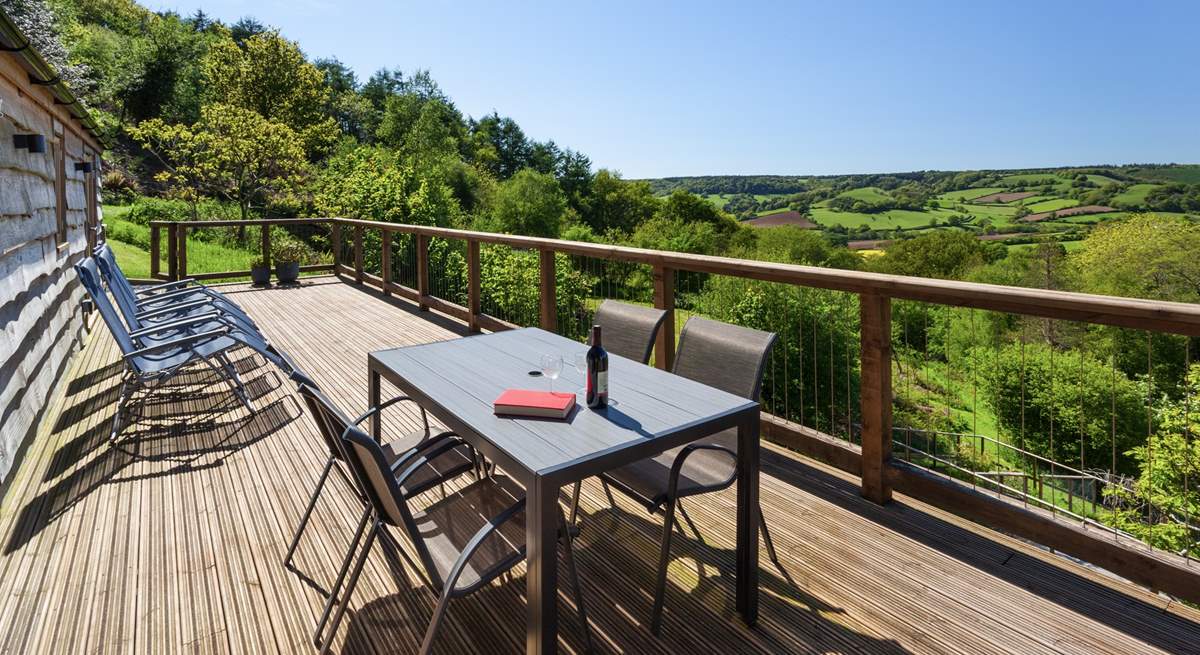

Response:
(590, 317), (779, 635)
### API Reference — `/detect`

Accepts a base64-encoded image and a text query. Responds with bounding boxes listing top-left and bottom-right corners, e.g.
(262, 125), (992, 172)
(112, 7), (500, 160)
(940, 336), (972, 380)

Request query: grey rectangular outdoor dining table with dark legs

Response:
(367, 328), (761, 655)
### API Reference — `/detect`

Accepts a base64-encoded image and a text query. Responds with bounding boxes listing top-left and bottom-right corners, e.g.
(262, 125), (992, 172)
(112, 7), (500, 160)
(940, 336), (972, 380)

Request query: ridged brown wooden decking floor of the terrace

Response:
(0, 278), (1200, 655)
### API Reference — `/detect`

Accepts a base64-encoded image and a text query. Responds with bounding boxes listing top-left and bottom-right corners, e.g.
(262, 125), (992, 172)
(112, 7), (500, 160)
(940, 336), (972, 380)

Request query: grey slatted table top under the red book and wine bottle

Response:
(370, 328), (758, 483)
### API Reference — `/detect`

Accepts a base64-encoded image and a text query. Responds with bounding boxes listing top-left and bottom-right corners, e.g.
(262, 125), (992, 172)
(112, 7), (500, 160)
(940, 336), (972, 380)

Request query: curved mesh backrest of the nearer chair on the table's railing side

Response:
(674, 317), (776, 401)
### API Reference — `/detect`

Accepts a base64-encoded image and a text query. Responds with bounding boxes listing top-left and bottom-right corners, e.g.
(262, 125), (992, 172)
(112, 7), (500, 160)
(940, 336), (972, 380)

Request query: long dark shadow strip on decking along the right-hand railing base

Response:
(762, 450), (1200, 653)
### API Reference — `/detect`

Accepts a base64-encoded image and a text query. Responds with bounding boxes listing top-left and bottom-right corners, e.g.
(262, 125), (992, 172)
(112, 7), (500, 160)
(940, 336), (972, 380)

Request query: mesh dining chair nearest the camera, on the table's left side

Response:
(320, 415), (592, 655)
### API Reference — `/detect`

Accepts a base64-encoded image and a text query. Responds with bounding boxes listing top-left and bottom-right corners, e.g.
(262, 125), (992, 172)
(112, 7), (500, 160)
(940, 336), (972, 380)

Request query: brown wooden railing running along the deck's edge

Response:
(151, 218), (1200, 602)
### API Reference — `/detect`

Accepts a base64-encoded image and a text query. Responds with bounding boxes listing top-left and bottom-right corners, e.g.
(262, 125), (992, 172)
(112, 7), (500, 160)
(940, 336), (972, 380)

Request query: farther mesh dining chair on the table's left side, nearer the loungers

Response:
(290, 384), (478, 644)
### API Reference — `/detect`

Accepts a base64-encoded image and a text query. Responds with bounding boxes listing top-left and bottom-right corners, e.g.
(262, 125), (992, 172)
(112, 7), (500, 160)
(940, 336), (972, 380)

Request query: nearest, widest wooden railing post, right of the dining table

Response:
(858, 289), (892, 504)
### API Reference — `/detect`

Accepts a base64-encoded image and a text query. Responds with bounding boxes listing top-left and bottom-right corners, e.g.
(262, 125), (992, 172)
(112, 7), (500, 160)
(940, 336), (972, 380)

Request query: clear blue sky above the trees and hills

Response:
(148, 0), (1200, 178)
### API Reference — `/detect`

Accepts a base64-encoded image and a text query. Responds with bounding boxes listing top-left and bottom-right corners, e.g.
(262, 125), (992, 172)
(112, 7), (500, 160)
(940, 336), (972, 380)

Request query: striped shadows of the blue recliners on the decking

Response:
(4, 357), (300, 554)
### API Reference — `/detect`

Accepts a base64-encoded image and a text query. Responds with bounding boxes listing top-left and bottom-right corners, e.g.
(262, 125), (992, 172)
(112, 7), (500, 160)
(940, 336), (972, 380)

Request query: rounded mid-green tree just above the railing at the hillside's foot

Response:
(493, 168), (566, 238)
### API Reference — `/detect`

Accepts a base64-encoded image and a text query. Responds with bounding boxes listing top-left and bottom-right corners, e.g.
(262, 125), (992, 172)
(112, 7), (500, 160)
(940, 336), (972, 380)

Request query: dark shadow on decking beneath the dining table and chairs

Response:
(324, 499), (907, 654)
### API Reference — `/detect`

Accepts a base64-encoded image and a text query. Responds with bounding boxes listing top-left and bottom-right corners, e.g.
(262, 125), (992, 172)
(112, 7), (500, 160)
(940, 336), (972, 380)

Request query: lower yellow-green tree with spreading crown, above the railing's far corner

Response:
(130, 104), (305, 220)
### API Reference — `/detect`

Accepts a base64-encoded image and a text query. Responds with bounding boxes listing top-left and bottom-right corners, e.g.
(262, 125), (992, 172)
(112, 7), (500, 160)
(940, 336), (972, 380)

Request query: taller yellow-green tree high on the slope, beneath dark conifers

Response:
(203, 31), (337, 158)
